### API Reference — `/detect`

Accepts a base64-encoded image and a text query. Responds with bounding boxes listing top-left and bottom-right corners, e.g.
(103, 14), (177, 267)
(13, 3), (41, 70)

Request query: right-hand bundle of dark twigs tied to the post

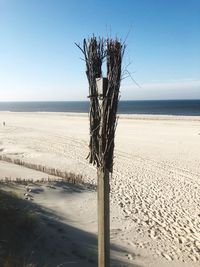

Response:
(102, 39), (125, 172)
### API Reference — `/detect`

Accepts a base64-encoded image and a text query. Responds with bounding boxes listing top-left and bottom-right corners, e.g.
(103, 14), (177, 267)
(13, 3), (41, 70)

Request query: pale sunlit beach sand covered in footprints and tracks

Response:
(0, 112), (200, 267)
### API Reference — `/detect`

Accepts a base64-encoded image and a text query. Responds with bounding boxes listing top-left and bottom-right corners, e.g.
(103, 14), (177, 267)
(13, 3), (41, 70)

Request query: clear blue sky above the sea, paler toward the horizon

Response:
(0, 0), (200, 101)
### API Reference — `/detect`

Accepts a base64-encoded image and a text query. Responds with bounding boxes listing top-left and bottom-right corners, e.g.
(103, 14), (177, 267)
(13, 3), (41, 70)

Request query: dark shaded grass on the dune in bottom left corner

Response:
(0, 190), (37, 267)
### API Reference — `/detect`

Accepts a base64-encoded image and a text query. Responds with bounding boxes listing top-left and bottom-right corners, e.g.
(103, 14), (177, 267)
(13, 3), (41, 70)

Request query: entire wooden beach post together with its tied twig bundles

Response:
(76, 37), (125, 267)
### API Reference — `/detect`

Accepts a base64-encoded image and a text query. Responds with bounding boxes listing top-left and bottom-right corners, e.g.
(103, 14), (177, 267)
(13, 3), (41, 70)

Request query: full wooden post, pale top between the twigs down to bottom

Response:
(96, 78), (110, 267)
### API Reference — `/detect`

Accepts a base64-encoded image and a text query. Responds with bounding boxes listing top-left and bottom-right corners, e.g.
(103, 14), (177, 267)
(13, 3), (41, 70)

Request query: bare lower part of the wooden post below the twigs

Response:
(97, 167), (110, 267)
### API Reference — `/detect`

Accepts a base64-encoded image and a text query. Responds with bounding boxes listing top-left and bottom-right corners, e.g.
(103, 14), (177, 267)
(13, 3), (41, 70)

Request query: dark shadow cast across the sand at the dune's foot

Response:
(0, 183), (140, 267)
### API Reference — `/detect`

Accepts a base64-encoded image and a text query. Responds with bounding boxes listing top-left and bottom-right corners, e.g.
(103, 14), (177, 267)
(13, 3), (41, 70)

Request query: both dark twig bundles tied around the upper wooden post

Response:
(76, 37), (125, 172)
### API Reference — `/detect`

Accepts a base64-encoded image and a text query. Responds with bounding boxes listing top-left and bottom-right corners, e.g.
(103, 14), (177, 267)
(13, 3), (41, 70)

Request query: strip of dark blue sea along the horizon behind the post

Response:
(0, 99), (200, 116)
